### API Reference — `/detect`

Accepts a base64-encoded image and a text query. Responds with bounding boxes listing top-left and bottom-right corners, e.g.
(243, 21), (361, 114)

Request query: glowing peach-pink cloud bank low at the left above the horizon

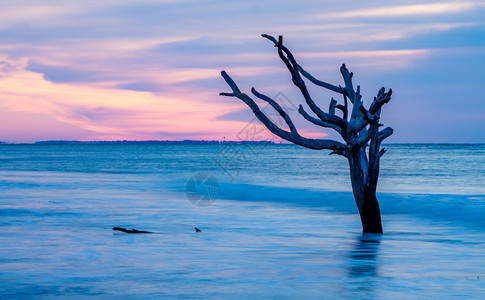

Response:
(0, 56), (240, 139)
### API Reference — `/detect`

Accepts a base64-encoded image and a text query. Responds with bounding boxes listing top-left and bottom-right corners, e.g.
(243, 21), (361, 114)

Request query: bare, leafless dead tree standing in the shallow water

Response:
(220, 34), (393, 233)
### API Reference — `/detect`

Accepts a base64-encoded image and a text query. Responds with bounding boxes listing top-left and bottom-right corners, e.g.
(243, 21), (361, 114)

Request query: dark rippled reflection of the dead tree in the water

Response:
(349, 233), (382, 278)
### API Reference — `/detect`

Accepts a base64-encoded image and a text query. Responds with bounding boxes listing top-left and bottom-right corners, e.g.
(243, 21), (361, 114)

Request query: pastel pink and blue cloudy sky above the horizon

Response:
(0, 0), (485, 143)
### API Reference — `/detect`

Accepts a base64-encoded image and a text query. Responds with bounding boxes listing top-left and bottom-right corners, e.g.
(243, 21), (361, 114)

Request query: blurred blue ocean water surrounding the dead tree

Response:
(0, 145), (485, 299)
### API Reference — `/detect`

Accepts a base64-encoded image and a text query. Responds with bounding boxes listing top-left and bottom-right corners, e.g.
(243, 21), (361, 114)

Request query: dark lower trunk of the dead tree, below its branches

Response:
(348, 149), (382, 233)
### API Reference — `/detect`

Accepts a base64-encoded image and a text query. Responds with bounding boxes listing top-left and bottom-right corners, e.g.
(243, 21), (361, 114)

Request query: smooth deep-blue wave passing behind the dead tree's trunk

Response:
(210, 183), (485, 229)
